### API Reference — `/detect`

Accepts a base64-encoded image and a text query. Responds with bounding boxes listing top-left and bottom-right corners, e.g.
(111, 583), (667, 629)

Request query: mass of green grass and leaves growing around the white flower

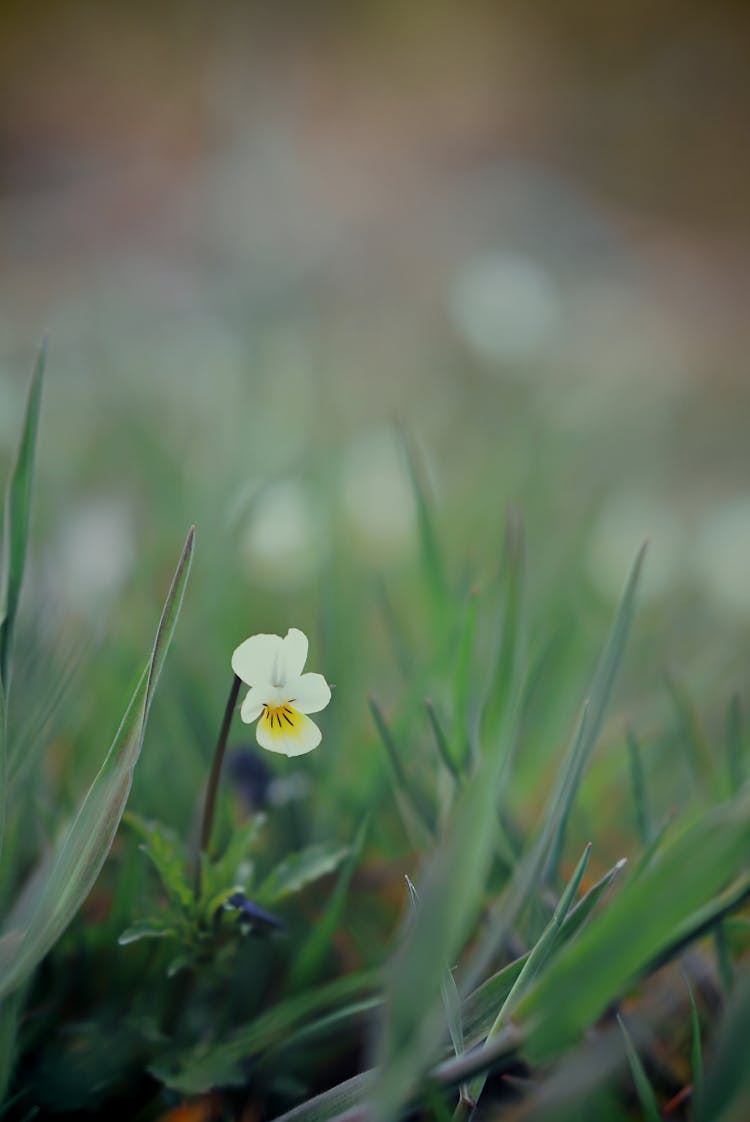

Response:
(0, 343), (750, 1122)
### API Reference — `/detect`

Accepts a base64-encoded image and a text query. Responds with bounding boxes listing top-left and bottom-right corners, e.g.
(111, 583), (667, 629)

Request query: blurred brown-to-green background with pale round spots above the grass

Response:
(0, 0), (750, 830)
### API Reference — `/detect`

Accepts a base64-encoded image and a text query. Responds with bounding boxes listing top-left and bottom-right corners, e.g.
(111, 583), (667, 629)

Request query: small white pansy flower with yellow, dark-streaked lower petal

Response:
(231, 627), (331, 756)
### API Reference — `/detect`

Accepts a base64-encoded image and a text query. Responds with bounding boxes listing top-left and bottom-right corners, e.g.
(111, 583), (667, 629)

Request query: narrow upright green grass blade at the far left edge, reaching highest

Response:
(0, 342), (47, 699)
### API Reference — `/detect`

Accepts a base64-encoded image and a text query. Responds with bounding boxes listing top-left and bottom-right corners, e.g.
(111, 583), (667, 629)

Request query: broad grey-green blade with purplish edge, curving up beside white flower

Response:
(0, 528), (194, 999)
